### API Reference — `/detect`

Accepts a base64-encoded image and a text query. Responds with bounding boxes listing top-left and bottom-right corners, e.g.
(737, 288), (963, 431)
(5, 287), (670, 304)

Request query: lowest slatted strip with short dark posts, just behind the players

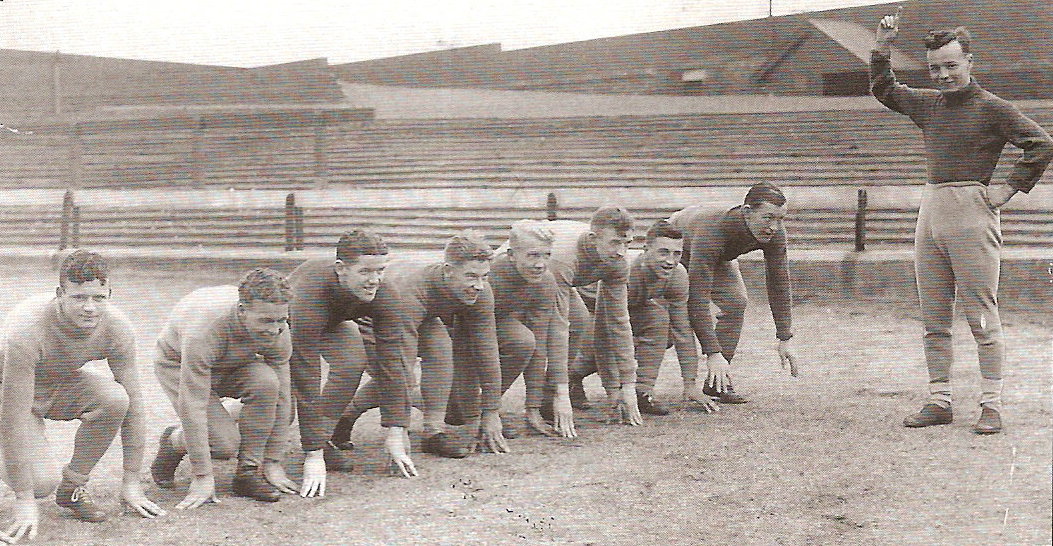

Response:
(0, 188), (1053, 251)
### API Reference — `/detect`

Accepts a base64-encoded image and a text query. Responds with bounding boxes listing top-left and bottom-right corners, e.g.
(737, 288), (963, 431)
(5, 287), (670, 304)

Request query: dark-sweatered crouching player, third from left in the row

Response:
(290, 229), (417, 497)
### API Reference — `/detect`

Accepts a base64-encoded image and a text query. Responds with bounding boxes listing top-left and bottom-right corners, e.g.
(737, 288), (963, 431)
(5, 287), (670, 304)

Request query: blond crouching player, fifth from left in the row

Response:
(446, 220), (577, 438)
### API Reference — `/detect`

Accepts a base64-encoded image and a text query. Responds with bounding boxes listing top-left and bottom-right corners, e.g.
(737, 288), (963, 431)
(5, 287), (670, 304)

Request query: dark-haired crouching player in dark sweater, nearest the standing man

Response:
(670, 182), (797, 404)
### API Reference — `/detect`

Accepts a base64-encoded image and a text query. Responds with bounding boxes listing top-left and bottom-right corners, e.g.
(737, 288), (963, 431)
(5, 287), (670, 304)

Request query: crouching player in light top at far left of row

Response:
(0, 250), (163, 542)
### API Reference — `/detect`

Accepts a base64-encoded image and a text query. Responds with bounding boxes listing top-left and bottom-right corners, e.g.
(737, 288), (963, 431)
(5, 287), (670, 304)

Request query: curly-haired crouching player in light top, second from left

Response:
(151, 268), (296, 509)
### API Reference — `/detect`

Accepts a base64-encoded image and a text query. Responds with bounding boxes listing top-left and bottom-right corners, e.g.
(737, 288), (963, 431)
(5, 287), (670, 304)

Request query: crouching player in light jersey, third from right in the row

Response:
(542, 206), (643, 426)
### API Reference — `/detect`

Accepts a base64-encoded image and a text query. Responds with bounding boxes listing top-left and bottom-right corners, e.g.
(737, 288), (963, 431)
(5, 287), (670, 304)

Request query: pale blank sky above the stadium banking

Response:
(0, 0), (897, 67)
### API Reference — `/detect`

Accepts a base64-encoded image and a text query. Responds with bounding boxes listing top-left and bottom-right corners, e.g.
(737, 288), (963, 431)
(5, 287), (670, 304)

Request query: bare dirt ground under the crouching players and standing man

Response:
(0, 263), (1053, 544)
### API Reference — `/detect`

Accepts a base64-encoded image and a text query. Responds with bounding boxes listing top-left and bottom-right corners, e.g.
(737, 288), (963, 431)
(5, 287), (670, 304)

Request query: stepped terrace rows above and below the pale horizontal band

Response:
(0, 105), (1053, 247)
